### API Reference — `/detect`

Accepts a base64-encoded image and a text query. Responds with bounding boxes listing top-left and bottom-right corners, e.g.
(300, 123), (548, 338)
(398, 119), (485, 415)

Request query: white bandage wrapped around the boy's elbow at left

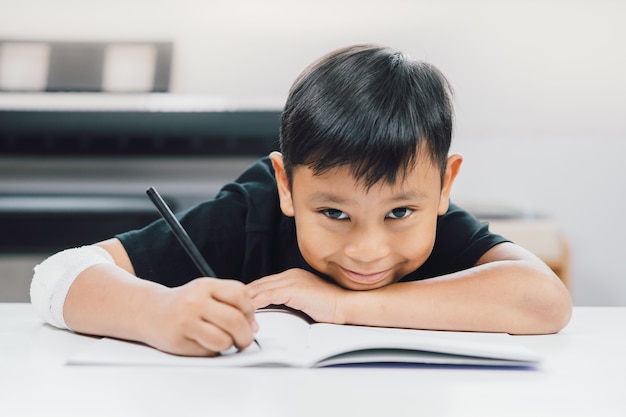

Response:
(30, 246), (115, 329)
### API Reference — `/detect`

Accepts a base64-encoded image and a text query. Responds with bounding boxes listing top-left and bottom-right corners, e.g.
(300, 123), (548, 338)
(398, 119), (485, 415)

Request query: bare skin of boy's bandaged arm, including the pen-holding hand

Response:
(37, 239), (256, 356)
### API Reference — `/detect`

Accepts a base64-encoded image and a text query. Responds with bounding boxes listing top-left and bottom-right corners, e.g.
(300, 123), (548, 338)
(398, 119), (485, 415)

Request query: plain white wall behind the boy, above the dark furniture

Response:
(0, 0), (626, 305)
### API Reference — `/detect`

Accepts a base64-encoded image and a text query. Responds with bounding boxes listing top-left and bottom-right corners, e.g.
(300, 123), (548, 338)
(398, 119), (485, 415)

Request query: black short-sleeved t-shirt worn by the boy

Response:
(116, 158), (506, 287)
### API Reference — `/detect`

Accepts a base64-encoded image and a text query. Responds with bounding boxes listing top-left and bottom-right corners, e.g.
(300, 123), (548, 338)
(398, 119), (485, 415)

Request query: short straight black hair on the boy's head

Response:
(280, 45), (454, 188)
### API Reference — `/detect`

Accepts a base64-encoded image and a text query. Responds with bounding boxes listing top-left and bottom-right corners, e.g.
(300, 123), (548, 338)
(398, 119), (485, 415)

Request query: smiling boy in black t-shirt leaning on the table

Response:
(31, 45), (571, 356)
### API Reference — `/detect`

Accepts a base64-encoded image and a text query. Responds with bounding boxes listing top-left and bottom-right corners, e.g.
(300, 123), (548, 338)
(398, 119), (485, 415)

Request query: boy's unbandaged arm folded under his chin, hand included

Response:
(249, 243), (572, 334)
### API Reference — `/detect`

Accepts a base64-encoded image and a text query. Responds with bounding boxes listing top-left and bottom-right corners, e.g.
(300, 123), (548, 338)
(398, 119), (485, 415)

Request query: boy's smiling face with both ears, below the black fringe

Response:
(272, 153), (462, 290)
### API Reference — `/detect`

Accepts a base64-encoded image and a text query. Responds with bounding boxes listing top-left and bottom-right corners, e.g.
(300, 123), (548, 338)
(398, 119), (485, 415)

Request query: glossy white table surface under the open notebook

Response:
(0, 303), (626, 417)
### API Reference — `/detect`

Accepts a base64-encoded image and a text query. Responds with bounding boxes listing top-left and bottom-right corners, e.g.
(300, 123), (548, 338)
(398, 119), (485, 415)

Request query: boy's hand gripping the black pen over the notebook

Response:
(143, 278), (258, 356)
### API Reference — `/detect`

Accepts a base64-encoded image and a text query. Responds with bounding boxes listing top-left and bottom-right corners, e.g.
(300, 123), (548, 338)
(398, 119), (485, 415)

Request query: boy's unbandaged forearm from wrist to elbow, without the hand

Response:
(344, 261), (571, 334)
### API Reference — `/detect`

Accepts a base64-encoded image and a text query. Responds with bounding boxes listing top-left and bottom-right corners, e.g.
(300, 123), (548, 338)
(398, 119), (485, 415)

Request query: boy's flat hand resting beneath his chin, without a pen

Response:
(248, 268), (347, 324)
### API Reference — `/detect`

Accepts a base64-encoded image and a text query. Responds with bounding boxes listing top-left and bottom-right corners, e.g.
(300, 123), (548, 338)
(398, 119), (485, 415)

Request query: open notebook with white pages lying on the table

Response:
(68, 309), (540, 368)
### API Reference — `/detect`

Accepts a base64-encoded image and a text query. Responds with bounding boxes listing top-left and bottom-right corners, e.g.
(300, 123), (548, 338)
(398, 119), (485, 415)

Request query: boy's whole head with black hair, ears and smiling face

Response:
(270, 45), (462, 290)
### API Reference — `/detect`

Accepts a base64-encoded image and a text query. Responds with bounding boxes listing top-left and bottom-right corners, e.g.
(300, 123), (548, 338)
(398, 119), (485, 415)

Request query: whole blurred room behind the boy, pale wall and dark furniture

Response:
(0, 0), (626, 305)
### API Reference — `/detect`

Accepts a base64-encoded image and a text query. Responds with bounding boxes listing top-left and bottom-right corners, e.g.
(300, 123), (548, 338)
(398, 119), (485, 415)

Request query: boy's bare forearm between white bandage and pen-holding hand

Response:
(63, 264), (164, 341)
